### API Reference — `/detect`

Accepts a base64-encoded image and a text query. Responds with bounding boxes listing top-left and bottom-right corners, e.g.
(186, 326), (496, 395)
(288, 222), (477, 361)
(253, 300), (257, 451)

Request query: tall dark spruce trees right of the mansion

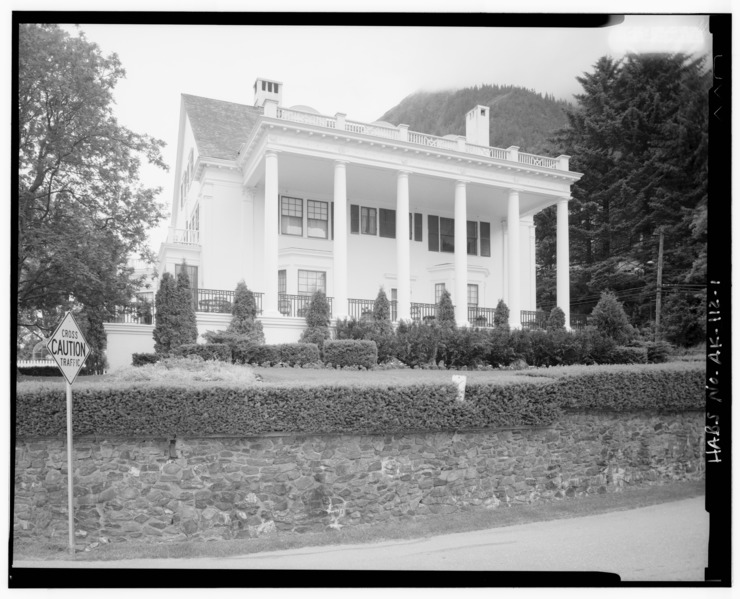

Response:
(535, 54), (711, 323)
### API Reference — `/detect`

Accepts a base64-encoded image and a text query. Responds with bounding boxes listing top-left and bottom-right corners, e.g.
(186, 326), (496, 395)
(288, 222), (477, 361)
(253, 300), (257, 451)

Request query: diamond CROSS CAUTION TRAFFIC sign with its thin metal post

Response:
(46, 312), (91, 556)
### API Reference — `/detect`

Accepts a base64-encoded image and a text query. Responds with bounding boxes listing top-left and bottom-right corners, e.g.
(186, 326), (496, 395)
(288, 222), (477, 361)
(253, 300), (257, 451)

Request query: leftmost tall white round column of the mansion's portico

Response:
(262, 150), (280, 316)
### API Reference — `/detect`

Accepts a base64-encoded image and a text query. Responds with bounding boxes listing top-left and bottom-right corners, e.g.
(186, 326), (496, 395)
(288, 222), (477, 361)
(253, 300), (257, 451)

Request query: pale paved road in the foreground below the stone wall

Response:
(14, 497), (709, 581)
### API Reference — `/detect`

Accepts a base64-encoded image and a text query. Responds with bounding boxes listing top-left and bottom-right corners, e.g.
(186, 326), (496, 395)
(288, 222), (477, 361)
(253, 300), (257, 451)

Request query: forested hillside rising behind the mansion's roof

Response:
(380, 85), (569, 154)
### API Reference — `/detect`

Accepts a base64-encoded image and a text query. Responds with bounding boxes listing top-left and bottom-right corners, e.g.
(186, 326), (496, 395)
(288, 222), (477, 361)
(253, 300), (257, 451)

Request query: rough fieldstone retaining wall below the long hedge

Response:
(13, 412), (704, 546)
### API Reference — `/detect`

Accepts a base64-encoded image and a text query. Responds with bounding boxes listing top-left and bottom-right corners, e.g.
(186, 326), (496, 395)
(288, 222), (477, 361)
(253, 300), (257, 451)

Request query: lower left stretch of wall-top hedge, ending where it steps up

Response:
(16, 383), (559, 437)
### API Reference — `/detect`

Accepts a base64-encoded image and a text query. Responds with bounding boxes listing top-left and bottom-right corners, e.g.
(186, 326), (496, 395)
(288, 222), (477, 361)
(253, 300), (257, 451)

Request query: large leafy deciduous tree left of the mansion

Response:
(15, 24), (166, 340)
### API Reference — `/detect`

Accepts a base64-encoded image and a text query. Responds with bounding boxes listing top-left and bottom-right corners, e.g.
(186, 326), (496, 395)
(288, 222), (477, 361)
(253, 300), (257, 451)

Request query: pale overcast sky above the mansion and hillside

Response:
(52, 15), (711, 250)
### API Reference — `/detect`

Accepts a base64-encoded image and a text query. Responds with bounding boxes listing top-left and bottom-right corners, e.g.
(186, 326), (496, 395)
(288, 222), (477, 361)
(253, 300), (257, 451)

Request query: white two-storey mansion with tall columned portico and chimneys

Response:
(106, 79), (581, 367)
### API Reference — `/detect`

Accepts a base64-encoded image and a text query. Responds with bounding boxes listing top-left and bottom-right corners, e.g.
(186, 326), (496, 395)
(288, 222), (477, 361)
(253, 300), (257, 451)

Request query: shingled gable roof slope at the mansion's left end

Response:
(182, 94), (262, 160)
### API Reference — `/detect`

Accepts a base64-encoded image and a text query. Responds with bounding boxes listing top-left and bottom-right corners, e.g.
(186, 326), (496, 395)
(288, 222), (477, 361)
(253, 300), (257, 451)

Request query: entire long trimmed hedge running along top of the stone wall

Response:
(16, 364), (705, 437)
